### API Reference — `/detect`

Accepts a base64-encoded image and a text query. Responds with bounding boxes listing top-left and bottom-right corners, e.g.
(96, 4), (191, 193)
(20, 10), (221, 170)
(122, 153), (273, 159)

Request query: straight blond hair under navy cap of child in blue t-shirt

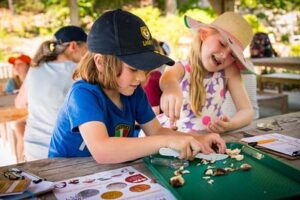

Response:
(73, 51), (122, 89)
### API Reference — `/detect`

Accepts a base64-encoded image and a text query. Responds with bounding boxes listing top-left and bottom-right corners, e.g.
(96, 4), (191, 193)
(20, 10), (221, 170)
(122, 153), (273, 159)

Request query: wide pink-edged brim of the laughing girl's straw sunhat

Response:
(184, 16), (255, 74)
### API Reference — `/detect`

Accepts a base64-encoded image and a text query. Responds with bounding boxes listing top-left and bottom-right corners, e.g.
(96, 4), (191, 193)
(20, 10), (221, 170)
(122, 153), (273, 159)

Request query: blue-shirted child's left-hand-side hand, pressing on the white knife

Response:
(167, 134), (204, 160)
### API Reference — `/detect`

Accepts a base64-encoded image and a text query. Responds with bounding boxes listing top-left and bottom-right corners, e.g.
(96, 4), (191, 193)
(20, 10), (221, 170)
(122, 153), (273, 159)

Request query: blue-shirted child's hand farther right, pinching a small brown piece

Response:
(196, 133), (226, 154)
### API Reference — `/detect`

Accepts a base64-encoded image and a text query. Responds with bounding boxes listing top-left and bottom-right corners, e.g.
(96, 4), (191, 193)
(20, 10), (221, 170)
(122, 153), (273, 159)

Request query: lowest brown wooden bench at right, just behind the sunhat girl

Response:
(257, 91), (288, 114)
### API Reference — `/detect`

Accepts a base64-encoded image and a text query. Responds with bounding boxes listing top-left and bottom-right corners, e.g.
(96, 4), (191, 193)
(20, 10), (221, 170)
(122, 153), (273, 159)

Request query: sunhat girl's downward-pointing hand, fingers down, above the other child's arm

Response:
(160, 85), (183, 124)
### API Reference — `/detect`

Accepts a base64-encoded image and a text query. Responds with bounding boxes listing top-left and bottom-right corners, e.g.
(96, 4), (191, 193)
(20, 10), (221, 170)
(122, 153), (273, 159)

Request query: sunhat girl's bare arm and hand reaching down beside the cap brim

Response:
(159, 63), (184, 122)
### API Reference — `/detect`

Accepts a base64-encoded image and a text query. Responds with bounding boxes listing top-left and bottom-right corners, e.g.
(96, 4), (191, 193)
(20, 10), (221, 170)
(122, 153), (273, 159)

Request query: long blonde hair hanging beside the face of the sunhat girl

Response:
(189, 35), (207, 117)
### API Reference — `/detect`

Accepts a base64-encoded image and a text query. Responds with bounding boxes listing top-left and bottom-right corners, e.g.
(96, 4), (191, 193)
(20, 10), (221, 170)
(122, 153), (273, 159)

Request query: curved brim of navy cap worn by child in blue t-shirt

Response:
(116, 51), (175, 71)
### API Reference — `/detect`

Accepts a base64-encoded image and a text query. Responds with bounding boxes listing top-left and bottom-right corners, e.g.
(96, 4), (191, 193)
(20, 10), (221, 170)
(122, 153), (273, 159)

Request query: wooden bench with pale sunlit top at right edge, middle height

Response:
(259, 73), (300, 93)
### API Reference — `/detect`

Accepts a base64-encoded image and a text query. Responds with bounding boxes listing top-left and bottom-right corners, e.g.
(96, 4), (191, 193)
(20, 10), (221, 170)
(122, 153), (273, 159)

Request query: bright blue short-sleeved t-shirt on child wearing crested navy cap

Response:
(48, 80), (155, 158)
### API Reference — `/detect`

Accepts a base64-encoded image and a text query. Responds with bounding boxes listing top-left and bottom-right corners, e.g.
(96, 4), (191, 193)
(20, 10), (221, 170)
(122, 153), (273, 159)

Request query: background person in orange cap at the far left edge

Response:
(5, 54), (31, 162)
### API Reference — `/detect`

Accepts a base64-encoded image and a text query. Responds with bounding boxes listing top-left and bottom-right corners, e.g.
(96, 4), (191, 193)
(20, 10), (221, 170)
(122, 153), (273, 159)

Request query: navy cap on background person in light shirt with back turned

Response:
(54, 26), (87, 43)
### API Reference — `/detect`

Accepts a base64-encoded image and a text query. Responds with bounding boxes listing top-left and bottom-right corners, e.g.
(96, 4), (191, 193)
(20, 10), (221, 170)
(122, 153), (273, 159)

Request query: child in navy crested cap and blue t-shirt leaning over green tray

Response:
(49, 10), (225, 163)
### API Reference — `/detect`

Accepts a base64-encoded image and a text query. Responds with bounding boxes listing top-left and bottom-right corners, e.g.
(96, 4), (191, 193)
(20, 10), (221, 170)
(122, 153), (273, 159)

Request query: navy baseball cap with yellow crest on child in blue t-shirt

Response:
(87, 9), (174, 71)
